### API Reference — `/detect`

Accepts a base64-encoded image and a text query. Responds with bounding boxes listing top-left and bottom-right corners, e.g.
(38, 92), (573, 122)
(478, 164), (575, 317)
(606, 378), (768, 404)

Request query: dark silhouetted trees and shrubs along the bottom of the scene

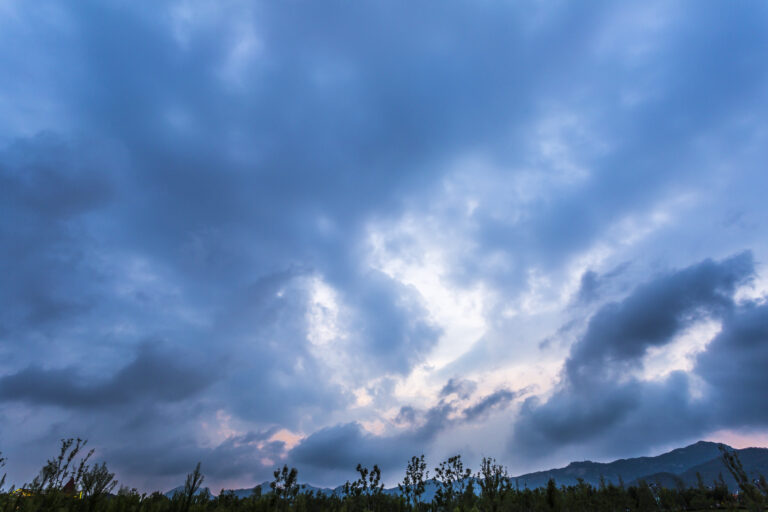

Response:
(0, 439), (768, 512)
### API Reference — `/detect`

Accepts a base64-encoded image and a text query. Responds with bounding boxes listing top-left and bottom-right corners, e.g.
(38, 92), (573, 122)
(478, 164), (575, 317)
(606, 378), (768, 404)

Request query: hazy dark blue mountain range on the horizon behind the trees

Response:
(166, 441), (768, 501)
